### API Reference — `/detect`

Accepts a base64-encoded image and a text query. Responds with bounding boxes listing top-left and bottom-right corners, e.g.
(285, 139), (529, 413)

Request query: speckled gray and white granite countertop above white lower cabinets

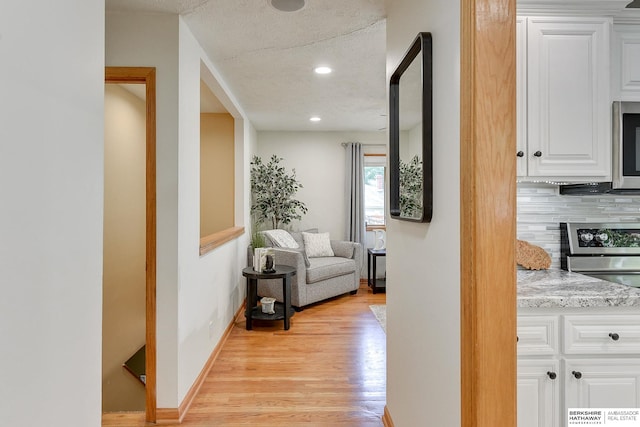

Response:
(517, 269), (640, 309)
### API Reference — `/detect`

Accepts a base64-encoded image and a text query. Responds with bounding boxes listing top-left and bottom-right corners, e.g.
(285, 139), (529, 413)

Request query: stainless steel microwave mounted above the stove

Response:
(560, 101), (640, 195)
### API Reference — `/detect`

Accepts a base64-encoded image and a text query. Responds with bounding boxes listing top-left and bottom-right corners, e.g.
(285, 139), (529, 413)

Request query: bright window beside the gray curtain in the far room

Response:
(364, 154), (387, 228)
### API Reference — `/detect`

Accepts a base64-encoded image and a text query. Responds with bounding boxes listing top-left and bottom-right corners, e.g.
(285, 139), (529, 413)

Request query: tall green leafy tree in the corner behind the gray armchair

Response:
(251, 154), (307, 229)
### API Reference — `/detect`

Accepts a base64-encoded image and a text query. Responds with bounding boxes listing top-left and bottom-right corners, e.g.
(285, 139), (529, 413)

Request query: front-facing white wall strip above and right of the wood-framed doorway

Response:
(105, 12), (178, 408)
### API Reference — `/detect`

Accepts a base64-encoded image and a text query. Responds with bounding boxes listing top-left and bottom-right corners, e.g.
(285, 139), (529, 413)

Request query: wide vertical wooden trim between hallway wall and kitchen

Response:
(460, 0), (516, 427)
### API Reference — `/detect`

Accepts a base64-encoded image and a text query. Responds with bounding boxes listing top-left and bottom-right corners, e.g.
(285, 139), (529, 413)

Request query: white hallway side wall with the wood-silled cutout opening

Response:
(178, 18), (252, 402)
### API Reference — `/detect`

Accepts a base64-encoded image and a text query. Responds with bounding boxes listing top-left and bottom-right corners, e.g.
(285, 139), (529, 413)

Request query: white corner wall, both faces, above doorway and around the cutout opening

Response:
(106, 13), (255, 408)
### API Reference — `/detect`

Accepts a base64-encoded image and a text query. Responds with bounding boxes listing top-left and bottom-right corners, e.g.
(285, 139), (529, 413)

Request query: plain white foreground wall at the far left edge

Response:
(0, 0), (104, 427)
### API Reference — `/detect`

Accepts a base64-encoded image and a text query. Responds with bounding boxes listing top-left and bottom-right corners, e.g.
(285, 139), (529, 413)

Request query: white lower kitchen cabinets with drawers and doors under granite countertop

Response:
(517, 307), (640, 427)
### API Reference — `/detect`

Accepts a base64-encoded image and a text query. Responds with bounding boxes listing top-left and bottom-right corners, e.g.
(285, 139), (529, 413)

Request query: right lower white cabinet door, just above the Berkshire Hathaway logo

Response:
(564, 358), (640, 408)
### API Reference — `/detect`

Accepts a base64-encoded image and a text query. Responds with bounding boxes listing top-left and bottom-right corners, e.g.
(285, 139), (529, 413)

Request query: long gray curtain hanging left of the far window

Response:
(345, 142), (366, 252)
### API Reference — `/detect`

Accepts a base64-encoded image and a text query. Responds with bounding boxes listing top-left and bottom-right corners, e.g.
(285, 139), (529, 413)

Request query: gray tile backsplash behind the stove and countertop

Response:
(517, 183), (640, 268)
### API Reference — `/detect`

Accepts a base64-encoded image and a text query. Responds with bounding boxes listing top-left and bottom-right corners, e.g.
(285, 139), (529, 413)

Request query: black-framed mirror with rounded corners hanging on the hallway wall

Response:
(389, 32), (433, 222)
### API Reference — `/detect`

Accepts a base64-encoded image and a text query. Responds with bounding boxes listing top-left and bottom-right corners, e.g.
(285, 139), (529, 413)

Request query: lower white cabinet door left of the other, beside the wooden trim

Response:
(518, 359), (561, 427)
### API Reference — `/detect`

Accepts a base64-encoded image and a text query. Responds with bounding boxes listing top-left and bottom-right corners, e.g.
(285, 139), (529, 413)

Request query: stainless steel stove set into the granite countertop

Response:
(560, 223), (640, 288)
